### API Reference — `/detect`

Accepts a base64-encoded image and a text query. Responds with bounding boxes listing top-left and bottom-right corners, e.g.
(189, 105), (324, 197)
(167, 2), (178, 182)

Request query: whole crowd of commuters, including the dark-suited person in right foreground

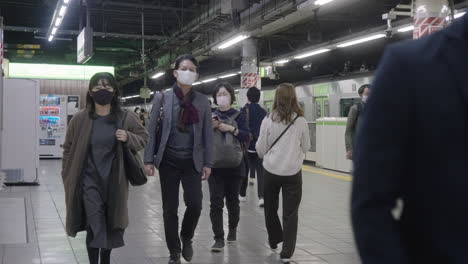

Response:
(62, 16), (468, 264)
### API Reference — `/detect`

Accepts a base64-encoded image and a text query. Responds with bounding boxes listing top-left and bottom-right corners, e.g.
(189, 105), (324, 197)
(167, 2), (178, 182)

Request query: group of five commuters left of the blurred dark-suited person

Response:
(62, 55), (310, 264)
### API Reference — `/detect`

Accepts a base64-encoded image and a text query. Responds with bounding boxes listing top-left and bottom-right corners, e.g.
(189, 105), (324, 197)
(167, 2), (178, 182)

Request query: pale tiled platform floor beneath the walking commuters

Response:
(0, 161), (360, 264)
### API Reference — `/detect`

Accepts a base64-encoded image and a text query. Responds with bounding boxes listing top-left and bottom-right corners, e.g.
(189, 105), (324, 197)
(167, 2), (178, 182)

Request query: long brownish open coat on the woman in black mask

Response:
(62, 110), (148, 237)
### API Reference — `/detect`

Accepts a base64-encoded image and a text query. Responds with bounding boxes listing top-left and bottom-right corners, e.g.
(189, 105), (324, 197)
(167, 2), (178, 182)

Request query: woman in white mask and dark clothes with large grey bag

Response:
(208, 83), (249, 252)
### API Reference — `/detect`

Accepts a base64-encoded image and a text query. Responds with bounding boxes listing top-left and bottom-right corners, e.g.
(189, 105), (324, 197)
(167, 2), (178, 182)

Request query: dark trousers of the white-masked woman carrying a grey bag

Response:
(208, 168), (242, 239)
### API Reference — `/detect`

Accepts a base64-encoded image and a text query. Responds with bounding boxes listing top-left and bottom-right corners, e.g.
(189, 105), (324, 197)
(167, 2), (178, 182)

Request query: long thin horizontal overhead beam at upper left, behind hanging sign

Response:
(4, 26), (166, 40)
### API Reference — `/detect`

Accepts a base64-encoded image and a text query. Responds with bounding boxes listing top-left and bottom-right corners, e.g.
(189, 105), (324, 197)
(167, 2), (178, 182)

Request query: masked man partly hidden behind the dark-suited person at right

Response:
(345, 84), (370, 160)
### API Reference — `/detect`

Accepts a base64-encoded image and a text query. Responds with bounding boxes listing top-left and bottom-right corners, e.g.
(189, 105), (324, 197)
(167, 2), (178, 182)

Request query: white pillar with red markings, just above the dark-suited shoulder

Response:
(413, 0), (450, 39)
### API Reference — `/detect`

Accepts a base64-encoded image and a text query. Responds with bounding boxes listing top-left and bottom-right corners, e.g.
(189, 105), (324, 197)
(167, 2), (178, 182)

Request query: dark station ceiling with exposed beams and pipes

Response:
(0, 0), (468, 100)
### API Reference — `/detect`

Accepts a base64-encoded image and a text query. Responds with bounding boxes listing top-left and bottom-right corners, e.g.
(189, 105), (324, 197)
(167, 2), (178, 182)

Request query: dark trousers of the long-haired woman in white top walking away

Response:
(265, 170), (302, 258)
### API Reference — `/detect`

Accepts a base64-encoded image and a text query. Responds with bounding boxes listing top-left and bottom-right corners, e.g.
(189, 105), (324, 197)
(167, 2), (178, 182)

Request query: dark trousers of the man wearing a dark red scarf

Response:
(159, 155), (203, 255)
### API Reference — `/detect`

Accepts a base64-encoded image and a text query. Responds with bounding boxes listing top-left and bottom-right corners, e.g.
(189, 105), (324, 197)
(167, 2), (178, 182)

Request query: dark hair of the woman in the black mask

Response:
(86, 72), (122, 116)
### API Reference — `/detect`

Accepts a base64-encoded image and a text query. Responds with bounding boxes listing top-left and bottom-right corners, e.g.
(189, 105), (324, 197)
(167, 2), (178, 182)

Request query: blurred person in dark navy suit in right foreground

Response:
(352, 15), (468, 264)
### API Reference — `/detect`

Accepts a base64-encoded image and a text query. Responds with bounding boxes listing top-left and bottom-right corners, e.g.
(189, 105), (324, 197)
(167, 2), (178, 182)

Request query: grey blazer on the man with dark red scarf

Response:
(145, 90), (213, 172)
